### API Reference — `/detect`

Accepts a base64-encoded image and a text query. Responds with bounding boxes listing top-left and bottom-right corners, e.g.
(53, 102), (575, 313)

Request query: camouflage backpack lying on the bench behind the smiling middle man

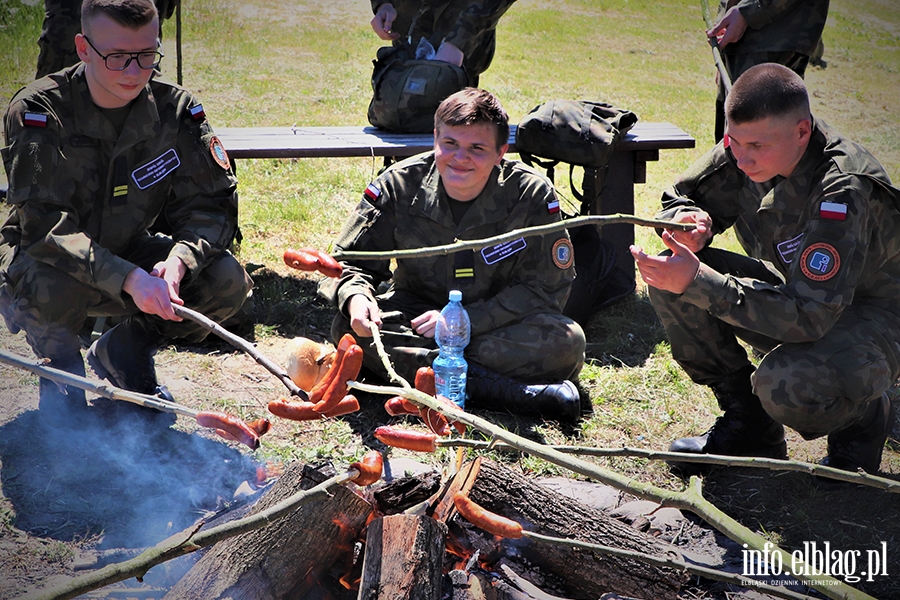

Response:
(516, 100), (638, 214)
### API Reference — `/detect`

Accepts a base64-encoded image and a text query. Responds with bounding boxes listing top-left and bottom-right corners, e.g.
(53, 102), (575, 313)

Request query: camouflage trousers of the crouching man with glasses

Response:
(0, 234), (253, 362)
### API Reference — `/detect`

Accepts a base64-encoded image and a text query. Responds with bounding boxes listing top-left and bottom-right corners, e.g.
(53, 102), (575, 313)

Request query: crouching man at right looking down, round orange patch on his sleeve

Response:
(632, 63), (900, 473)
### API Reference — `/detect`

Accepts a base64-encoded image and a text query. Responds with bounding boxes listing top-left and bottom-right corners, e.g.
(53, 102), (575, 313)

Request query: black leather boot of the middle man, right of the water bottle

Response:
(466, 363), (581, 423)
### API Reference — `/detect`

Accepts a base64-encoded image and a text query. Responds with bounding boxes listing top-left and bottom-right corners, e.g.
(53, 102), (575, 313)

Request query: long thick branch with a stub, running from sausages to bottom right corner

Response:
(349, 382), (875, 600)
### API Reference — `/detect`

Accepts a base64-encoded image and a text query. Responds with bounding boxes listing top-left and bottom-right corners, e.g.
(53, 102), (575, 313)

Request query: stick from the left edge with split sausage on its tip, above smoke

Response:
(0, 350), (259, 450)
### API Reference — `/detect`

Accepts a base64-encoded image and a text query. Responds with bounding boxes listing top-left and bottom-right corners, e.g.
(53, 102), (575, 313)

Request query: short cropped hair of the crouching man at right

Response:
(725, 63), (809, 124)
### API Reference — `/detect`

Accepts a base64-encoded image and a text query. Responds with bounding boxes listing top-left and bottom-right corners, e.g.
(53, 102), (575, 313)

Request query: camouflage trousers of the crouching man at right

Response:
(650, 248), (900, 439)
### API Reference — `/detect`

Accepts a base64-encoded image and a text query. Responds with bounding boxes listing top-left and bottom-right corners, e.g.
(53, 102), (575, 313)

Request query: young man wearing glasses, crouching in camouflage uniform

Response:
(0, 0), (251, 425)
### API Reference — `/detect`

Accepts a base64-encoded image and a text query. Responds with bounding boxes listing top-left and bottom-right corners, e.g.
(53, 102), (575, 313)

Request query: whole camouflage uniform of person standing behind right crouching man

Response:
(716, 0), (829, 141)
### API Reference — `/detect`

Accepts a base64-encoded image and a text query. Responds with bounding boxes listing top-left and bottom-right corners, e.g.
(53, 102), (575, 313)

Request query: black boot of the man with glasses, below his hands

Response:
(87, 316), (175, 422)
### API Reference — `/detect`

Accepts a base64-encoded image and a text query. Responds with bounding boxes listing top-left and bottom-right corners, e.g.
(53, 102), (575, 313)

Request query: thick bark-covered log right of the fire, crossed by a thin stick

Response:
(460, 460), (687, 600)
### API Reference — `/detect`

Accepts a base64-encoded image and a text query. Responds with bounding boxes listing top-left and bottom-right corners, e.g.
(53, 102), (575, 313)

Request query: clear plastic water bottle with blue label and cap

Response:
(432, 290), (471, 408)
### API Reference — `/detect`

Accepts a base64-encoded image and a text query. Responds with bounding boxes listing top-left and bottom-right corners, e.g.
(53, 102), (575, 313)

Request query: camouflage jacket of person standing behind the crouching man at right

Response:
(718, 0), (829, 56)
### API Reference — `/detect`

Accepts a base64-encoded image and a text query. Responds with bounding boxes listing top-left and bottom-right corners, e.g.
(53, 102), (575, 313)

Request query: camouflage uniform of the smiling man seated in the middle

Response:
(320, 153), (584, 382)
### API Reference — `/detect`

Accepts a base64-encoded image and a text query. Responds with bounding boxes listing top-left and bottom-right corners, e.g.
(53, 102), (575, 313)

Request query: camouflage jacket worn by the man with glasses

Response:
(0, 63), (237, 298)
